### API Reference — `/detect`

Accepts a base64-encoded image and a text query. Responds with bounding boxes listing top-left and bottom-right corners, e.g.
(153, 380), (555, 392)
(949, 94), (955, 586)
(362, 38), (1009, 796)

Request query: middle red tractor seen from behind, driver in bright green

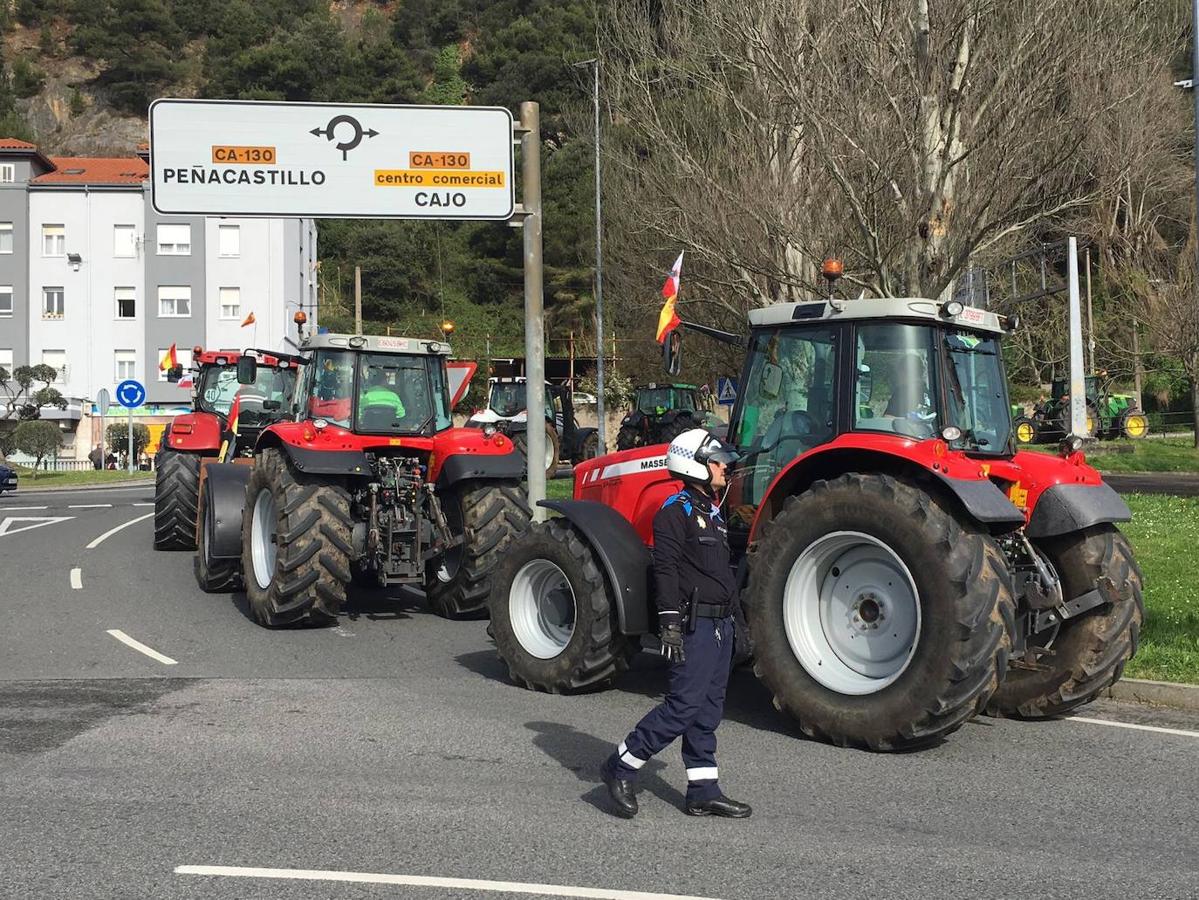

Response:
(195, 334), (530, 626)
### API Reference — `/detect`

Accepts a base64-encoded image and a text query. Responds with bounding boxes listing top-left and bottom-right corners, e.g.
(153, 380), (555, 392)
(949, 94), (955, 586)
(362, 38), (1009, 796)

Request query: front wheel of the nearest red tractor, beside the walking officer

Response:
(488, 519), (639, 694)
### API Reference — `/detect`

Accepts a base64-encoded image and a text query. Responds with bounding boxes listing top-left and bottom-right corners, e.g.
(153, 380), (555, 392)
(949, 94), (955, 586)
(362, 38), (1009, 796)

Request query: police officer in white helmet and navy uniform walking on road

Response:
(600, 428), (751, 819)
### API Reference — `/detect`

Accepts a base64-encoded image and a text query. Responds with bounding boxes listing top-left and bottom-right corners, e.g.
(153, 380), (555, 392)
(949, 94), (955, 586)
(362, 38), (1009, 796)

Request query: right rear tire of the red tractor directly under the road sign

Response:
(426, 482), (532, 618)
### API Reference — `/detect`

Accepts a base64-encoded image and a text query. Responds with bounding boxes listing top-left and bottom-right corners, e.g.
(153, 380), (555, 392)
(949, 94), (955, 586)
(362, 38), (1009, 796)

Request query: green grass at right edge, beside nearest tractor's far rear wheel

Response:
(1120, 494), (1199, 683)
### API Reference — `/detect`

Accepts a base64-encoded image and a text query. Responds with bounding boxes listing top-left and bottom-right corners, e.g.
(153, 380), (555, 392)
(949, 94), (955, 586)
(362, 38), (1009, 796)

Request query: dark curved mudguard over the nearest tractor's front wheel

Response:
(537, 500), (653, 634)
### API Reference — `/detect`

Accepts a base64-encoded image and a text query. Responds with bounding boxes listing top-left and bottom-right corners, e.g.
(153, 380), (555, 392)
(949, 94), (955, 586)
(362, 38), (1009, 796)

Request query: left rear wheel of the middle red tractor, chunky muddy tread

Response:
(241, 448), (354, 628)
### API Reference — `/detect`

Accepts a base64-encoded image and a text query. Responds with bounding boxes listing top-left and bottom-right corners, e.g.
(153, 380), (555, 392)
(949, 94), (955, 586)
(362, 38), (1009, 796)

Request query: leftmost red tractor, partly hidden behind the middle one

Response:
(153, 346), (299, 550)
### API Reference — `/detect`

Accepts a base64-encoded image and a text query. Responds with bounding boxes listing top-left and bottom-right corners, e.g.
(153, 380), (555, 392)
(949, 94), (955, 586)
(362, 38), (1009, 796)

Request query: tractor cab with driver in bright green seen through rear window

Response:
(291, 334), (453, 436)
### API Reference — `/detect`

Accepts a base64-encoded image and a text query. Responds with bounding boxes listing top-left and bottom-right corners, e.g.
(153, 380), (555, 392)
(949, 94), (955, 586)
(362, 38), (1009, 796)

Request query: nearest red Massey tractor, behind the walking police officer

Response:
(489, 298), (1144, 750)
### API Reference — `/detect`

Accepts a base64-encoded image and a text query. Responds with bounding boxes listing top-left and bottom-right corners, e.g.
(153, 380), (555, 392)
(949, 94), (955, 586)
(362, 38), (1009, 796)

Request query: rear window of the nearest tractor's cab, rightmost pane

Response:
(945, 331), (1012, 453)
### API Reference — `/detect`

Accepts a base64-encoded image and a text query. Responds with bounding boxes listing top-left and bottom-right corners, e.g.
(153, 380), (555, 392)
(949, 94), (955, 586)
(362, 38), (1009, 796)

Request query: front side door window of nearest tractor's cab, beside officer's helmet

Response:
(729, 326), (837, 506)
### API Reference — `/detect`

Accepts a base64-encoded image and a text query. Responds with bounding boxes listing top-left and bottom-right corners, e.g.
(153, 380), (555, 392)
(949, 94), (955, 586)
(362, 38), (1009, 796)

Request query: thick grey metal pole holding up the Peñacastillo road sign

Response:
(520, 101), (556, 521)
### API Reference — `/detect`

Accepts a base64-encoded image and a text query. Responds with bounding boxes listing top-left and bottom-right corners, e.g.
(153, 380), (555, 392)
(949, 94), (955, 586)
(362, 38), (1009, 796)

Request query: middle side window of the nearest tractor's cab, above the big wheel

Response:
(854, 322), (940, 439)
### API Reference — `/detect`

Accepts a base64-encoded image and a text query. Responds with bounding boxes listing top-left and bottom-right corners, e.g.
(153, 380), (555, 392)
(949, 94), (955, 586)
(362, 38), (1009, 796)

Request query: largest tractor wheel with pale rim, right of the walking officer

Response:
(743, 475), (1014, 750)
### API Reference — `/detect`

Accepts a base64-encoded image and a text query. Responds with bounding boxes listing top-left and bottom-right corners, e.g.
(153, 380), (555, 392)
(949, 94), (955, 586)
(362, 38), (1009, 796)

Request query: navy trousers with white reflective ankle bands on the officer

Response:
(605, 617), (733, 802)
